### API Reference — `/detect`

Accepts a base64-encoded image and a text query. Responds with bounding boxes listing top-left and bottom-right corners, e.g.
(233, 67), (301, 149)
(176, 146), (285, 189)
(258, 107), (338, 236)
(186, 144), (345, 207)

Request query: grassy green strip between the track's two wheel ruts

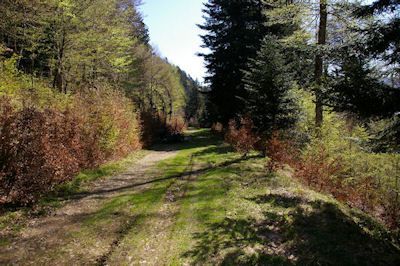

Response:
(2, 132), (212, 265)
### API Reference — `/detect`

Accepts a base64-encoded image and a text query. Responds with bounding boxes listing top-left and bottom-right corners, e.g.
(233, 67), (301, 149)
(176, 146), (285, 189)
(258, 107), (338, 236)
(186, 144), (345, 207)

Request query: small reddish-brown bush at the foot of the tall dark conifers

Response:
(225, 118), (260, 155)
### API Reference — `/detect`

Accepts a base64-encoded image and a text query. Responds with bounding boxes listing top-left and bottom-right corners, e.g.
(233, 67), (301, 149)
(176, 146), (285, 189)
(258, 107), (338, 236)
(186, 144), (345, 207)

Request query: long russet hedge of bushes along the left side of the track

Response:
(0, 90), (141, 204)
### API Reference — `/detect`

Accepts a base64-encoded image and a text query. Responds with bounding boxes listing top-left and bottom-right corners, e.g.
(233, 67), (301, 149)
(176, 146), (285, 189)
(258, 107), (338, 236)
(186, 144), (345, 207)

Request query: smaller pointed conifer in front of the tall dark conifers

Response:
(245, 37), (297, 136)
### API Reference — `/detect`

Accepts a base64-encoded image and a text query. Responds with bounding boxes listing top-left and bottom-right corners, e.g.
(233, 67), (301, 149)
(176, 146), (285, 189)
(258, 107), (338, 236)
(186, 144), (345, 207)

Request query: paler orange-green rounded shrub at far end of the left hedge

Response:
(72, 89), (142, 162)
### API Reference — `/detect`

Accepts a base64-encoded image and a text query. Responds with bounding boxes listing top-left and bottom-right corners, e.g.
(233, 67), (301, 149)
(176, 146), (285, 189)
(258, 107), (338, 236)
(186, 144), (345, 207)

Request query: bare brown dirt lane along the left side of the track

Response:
(0, 146), (178, 265)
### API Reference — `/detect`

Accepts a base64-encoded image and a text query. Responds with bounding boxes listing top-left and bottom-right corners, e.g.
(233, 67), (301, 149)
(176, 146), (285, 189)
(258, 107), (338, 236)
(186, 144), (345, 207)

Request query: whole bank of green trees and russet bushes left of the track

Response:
(0, 0), (197, 207)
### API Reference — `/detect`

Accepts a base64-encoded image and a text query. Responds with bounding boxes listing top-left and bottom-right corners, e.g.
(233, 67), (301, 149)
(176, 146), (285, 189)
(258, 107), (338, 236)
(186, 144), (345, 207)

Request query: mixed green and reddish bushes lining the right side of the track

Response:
(266, 90), (400, 229)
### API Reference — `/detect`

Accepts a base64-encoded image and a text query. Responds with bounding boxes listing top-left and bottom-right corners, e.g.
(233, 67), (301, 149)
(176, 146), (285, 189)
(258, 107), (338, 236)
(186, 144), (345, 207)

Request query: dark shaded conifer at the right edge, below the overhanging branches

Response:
(327, 52), (400, 119)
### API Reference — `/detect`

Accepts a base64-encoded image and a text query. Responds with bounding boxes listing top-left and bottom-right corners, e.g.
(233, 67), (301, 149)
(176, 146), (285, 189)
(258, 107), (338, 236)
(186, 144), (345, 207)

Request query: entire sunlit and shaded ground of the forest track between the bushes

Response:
(0, 130), (400, 265)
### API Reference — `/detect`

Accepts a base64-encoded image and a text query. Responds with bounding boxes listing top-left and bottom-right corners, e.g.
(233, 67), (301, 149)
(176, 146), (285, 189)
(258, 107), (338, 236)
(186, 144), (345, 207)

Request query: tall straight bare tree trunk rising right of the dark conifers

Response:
(315, 0), (328, 128)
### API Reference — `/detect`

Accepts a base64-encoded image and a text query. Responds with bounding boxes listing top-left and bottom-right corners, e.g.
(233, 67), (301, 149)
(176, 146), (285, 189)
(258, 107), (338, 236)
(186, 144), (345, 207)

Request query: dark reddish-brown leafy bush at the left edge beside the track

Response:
(0, 102), (81, 204)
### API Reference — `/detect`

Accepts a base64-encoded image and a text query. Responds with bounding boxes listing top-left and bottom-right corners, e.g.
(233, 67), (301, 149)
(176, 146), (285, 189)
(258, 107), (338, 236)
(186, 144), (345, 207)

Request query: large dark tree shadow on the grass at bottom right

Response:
(183, 194), (400, 266)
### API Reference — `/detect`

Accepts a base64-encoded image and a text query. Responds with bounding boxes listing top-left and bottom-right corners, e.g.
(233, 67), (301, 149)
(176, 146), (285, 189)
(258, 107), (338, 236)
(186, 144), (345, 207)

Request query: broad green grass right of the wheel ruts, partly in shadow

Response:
(108, 131), (400, 265)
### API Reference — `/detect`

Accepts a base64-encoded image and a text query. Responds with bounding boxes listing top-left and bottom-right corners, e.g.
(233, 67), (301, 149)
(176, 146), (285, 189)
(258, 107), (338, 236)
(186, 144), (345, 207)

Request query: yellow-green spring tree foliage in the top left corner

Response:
(0, 0), (152, 92)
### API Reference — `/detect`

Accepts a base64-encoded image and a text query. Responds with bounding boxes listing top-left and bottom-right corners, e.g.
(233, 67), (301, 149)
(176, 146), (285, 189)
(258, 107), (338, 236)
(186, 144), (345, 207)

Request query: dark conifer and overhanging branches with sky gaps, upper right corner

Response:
(326, 0), (400, 118)
